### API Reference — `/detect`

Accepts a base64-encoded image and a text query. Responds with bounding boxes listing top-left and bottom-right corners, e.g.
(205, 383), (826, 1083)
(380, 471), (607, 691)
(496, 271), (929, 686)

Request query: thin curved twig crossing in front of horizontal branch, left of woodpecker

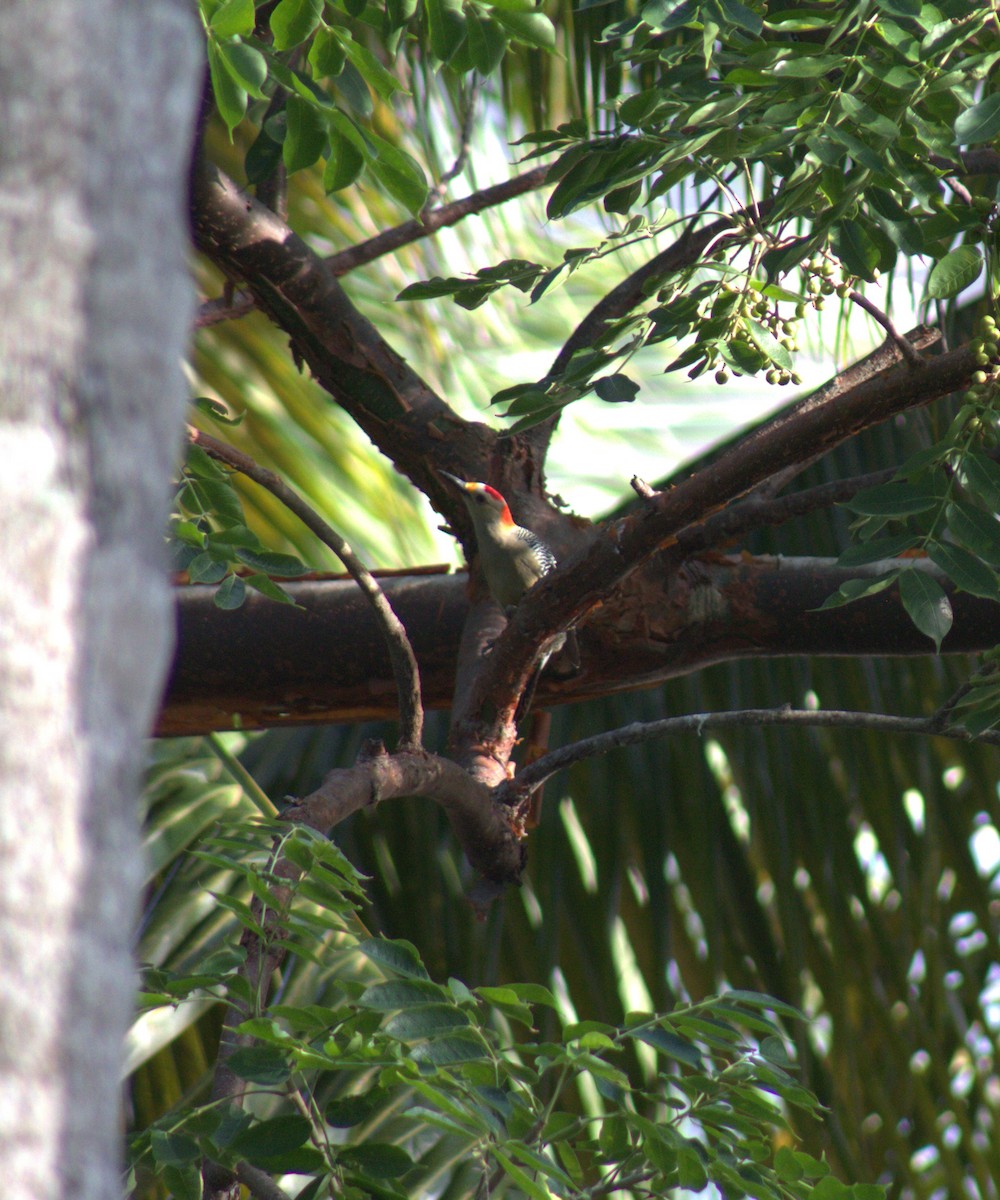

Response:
(188, 428), (424, 749)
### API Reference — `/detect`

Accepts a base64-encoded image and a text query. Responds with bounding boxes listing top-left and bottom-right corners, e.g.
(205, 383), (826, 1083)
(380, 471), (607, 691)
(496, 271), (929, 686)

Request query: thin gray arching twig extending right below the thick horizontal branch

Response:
(495, 707), (1000, 804)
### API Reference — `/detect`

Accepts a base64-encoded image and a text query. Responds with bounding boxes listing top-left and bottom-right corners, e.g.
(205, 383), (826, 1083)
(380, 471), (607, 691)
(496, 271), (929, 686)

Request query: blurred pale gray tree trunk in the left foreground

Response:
(0, 0), (199, 1200)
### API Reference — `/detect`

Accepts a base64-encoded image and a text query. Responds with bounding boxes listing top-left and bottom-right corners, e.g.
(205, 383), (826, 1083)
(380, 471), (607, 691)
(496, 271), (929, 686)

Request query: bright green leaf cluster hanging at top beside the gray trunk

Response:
(199, 0), (555, 214)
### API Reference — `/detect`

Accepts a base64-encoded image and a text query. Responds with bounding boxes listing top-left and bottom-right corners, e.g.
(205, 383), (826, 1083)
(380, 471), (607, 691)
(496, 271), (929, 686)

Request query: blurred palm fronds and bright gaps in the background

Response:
(138, 0), (1000, 1198)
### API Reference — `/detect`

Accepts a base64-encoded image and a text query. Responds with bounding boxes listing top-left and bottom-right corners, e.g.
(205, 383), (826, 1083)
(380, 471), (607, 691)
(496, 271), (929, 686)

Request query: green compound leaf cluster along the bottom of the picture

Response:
(130, 823), (882, 1200)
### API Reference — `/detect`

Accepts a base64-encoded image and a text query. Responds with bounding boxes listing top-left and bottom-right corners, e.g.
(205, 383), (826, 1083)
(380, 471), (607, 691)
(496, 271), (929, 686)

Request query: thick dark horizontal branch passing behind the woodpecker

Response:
(158, 556), (1000, 734)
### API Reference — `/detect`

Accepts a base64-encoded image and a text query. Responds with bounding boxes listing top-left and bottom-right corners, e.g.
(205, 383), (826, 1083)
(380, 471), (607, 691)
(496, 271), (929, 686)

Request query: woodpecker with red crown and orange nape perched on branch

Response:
(442, 470), (558, 609)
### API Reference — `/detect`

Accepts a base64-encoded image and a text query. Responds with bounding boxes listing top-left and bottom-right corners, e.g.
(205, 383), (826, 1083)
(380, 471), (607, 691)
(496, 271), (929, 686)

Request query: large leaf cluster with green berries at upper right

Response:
(403, 0), (1000, 427)
